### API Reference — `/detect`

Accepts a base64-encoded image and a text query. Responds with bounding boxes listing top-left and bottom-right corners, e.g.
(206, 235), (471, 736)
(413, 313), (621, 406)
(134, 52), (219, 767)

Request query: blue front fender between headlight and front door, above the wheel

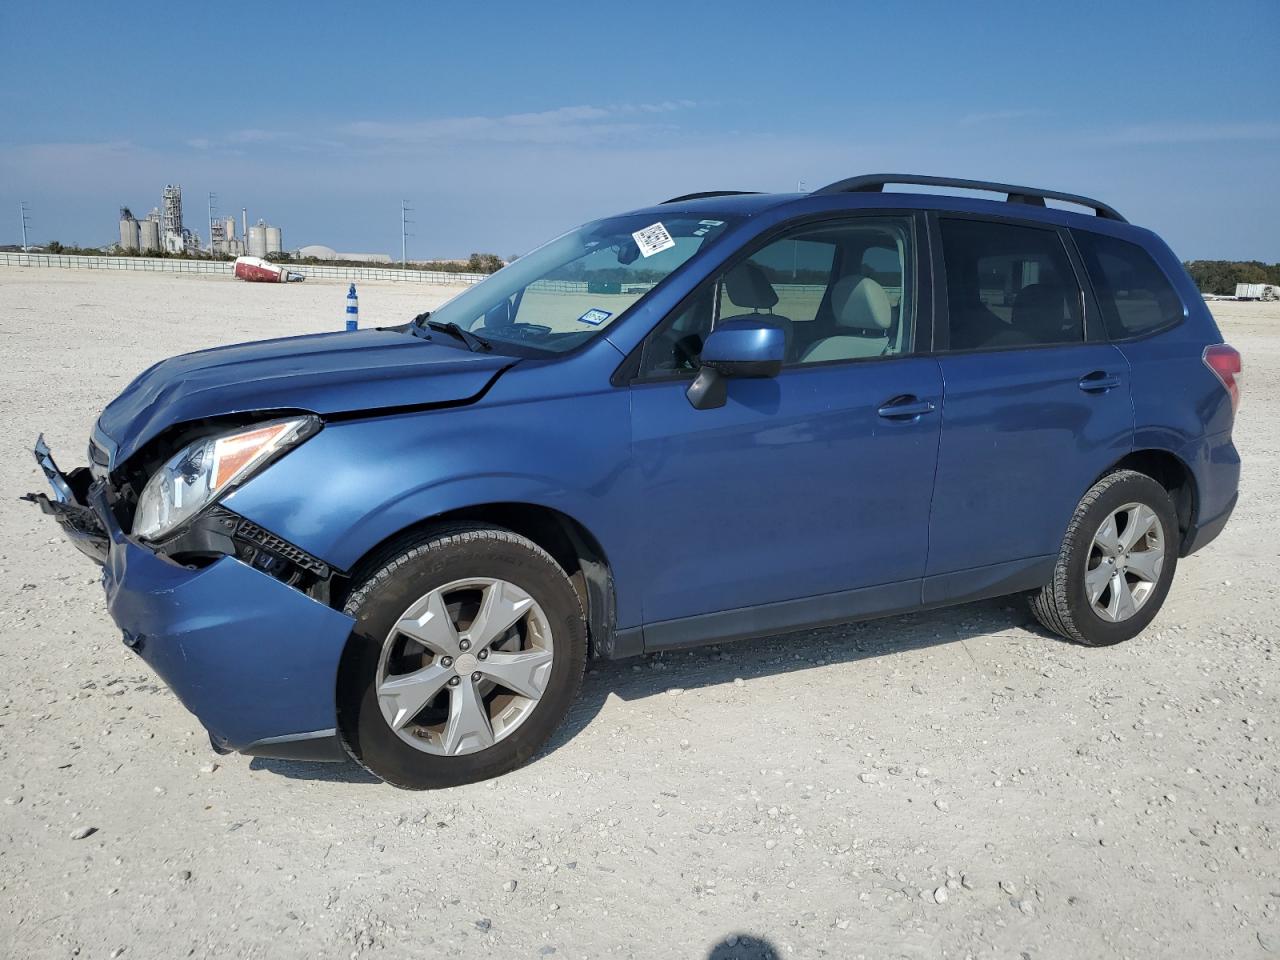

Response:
(227, 389), (640, 623)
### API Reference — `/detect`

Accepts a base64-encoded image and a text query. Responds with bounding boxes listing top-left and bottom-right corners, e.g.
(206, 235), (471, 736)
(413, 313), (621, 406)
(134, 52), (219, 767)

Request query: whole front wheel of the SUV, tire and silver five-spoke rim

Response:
(338, 525), (586, 790)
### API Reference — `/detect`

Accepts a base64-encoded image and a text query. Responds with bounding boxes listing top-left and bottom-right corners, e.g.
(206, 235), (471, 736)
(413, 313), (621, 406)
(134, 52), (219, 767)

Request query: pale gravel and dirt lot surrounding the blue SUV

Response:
(0, 269), (1280, 960)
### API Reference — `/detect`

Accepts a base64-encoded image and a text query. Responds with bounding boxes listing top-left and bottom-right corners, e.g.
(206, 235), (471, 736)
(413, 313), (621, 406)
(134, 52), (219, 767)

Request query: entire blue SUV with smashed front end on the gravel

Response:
(29, 175), (1240, 788)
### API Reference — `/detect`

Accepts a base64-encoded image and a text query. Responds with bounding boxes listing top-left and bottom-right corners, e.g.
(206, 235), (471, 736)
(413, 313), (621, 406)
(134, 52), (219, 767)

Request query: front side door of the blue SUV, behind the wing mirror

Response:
(630, 215), (942, 649)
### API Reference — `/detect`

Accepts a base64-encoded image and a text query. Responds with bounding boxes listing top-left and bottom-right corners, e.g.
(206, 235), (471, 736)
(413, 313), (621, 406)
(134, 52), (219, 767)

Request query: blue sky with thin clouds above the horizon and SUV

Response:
(0, 0), (1280, 261)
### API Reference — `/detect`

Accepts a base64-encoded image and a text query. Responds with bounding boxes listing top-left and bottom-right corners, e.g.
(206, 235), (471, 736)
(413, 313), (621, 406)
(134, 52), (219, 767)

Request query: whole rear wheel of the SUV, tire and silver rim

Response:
(1032, 470), (1178, 646)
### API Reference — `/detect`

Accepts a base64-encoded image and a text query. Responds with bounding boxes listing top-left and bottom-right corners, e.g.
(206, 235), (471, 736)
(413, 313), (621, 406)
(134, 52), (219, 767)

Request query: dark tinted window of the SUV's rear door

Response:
(941, 219), (1084, 349)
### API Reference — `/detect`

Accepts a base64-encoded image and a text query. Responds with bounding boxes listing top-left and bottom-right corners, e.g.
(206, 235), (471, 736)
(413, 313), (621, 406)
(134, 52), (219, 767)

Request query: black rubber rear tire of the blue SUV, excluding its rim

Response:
(1030, 470), (1179, 646)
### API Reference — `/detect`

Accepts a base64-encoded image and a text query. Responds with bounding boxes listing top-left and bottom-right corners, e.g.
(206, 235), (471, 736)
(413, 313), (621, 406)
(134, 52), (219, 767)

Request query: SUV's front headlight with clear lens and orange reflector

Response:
(133, 417), (319, 540)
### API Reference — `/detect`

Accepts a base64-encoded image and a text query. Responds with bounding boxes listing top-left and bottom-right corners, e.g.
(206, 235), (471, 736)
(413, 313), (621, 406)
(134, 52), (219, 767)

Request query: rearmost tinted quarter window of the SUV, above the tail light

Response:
(1074, 230), (1183, 340)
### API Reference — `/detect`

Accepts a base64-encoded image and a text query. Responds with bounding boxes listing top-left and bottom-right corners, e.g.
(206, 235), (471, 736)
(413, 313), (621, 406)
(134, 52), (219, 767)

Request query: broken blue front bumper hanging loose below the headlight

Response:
(24, 438), (353, 760)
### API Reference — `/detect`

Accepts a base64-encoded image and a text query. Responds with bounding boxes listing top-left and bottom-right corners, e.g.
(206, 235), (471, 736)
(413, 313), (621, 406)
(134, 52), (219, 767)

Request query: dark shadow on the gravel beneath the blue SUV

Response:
(250, 596), (1047, 783)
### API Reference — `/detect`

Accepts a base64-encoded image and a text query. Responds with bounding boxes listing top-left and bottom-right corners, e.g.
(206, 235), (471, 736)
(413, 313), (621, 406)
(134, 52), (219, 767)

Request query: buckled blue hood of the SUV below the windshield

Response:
(97, 330), (517, 467)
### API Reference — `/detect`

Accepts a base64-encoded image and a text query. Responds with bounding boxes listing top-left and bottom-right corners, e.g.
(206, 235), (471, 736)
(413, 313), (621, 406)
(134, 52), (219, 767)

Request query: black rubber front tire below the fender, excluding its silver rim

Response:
(338, 524), (588, 790)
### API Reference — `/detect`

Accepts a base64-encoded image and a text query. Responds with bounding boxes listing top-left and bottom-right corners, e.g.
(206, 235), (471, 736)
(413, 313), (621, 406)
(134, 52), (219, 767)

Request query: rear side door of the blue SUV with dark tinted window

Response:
(925, 215), (1133, 602)
